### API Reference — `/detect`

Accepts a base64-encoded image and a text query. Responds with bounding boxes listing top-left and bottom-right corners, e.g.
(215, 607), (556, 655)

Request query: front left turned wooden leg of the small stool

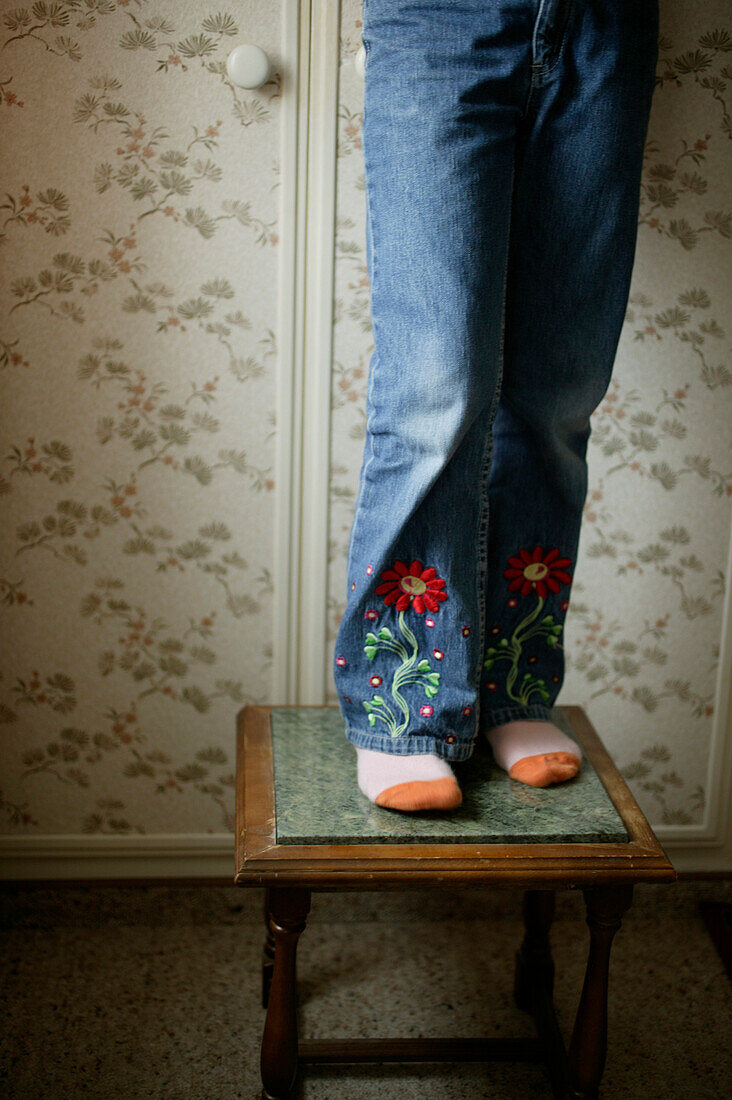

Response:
(260, 887), (310, 1100)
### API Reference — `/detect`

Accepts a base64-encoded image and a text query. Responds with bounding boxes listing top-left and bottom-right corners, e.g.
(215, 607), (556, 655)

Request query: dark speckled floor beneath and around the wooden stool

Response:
(0, 881), (732, 1100)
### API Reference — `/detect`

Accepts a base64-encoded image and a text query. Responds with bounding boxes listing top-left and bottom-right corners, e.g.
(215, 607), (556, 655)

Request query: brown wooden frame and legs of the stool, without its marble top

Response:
(234, 706), (676, 1100)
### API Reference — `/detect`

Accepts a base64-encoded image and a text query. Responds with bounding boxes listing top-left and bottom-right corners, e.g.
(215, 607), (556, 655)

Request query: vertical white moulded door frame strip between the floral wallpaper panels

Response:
(272, 0), (340, 705)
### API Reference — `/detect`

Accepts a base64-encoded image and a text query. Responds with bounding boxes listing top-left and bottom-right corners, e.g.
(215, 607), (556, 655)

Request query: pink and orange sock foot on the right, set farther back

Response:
(485, 719), (582, 787)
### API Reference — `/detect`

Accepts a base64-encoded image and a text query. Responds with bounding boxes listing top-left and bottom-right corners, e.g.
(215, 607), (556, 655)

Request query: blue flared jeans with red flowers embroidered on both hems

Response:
(334, 0), (658, 760)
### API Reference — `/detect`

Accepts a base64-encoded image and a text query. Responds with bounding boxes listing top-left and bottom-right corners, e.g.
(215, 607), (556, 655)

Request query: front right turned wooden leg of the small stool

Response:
(569, 886), (633, 1100)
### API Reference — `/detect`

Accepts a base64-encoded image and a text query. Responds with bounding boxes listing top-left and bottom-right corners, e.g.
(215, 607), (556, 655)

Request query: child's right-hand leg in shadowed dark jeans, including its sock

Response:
(481, 0), (658, 785)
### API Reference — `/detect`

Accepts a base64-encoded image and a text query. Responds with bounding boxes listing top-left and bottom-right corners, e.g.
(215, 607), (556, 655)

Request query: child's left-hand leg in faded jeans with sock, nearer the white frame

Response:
(334, 0), (521, 807)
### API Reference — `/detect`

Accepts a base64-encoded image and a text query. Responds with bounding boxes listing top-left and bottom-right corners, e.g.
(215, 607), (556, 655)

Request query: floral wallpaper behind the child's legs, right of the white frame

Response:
(328, 0), (732, 826)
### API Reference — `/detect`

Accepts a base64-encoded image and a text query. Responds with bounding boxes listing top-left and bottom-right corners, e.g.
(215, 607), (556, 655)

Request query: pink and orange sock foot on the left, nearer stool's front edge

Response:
(356, 746), (462, 811)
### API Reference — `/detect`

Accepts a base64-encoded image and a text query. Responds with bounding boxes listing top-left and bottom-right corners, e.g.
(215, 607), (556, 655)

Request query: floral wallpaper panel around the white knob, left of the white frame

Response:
(0, 0), (281, 835)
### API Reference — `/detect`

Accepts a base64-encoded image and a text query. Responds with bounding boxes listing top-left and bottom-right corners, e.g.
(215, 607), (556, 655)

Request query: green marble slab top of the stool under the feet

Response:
(271, 706), (629, 845)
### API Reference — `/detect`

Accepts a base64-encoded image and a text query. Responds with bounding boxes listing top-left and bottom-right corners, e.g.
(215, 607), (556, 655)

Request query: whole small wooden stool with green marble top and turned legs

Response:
(234, 706), (676, 1100)
